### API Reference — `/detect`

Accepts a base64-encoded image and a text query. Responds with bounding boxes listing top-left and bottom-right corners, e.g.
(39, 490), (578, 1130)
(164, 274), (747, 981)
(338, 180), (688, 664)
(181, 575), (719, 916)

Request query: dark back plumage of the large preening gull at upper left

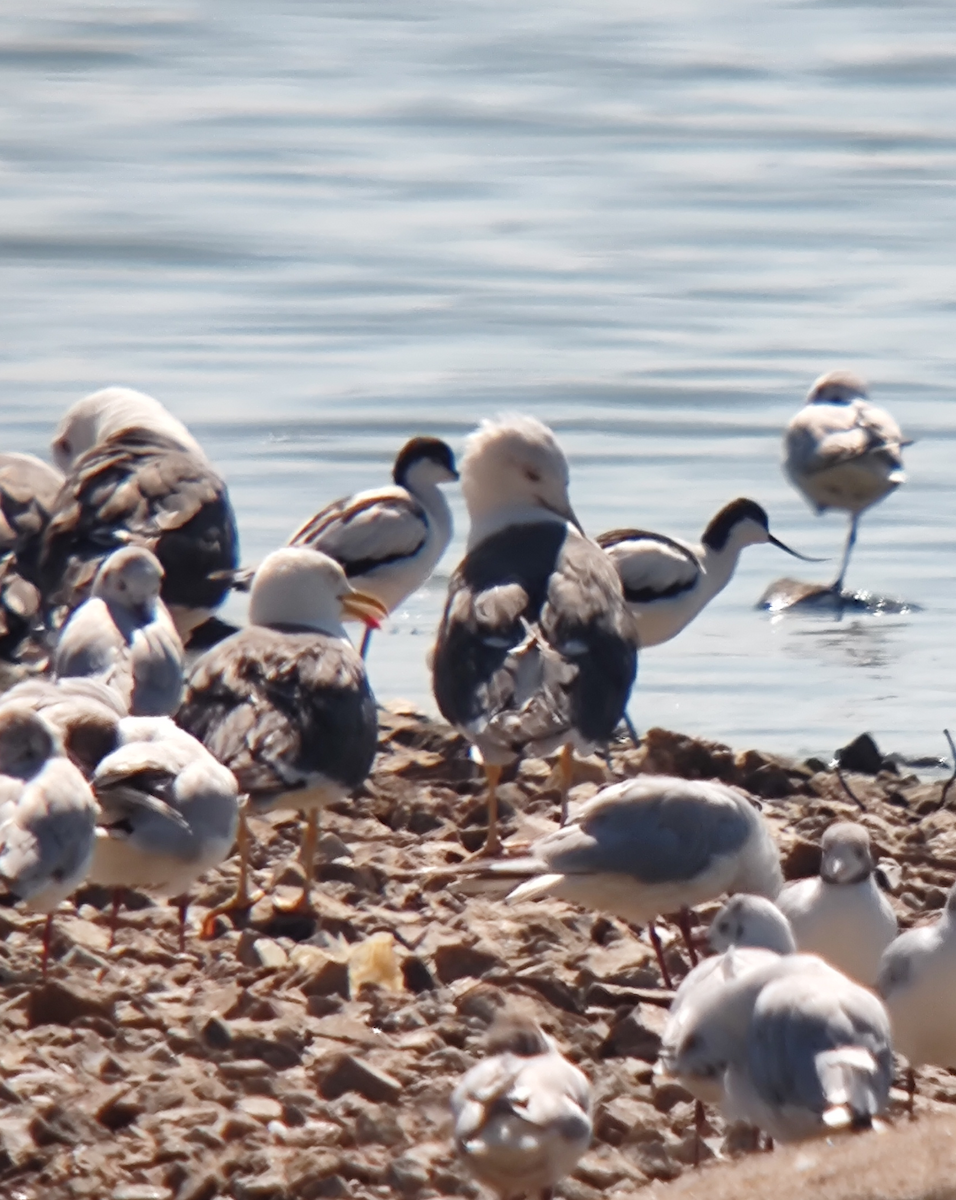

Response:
(38, 430), (239, 610)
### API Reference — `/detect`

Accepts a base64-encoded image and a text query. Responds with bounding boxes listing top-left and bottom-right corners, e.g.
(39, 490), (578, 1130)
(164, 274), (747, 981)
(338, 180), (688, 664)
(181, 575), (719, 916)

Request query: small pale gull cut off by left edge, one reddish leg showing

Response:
(0, 704), (97, 976)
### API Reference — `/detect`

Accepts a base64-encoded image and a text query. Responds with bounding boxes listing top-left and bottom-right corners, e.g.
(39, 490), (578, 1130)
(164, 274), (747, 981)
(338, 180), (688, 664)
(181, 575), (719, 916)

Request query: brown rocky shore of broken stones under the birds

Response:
(0, 704), (956, 1200)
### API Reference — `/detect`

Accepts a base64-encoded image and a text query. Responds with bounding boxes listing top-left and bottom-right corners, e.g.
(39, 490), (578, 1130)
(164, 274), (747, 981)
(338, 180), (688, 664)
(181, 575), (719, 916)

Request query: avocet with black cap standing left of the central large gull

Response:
(289, 438), (458, 658)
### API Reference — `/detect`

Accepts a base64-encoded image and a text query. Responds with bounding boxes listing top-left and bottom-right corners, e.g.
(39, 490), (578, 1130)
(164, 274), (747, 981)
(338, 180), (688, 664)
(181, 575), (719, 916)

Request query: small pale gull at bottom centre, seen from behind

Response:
(451, 1016), (591, 1200)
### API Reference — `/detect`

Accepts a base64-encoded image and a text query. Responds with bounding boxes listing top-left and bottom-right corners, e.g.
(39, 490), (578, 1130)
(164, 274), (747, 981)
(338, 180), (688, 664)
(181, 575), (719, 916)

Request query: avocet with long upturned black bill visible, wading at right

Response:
(596, 499), (816, 650)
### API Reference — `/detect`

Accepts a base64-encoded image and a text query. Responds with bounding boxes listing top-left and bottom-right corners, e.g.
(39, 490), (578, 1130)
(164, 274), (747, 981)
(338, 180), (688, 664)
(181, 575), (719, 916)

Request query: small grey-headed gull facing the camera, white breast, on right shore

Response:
(777, 821), (898, 988)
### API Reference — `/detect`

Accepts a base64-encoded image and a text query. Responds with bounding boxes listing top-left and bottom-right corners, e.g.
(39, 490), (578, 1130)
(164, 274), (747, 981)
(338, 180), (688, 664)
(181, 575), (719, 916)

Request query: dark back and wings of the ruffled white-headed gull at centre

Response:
(433, 522), (637, 752)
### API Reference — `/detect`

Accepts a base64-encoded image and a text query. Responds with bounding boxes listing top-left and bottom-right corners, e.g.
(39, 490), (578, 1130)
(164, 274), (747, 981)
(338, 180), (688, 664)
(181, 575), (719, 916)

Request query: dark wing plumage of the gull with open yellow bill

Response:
(176, 625), (378, 796)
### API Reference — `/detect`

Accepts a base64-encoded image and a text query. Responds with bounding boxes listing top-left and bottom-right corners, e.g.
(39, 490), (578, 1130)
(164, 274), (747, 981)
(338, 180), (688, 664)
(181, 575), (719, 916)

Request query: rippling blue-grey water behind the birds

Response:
(0, 0), (956, 754)
